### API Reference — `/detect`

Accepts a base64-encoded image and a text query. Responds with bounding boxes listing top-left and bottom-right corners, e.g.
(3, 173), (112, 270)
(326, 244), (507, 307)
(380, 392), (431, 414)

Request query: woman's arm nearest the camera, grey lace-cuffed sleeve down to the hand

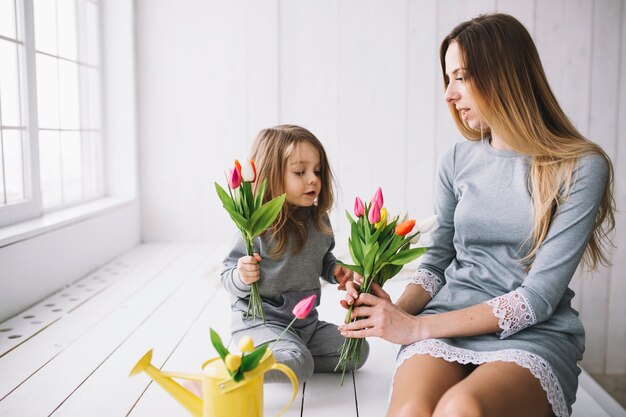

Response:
(340, 156), (607, 344)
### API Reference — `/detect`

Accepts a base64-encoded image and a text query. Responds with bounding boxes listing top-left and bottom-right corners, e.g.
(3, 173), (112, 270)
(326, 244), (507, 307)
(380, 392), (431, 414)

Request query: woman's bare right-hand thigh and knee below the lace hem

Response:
(433, 362), (553, 417)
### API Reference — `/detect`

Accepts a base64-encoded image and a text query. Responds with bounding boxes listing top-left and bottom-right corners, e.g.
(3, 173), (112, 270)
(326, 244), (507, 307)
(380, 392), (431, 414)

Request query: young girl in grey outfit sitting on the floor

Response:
(221, 125), (368, 382)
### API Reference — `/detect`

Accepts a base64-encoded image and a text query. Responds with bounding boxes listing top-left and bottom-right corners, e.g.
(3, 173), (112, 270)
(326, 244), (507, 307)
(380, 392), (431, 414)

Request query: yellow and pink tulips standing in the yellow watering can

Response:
(211, 295), (317, 382)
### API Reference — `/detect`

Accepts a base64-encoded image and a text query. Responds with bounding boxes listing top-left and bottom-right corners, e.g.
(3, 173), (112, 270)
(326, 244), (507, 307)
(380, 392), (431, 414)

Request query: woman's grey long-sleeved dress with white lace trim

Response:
(397, 139), (608, 417)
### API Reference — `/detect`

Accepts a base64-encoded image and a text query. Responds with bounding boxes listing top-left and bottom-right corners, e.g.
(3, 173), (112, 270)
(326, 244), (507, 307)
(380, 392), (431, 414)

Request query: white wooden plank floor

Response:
(0, 244), (626, 417)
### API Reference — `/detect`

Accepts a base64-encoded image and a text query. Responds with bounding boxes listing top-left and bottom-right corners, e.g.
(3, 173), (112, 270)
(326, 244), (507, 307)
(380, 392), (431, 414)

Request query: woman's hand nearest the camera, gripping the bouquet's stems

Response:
(339, 290), (423, 345)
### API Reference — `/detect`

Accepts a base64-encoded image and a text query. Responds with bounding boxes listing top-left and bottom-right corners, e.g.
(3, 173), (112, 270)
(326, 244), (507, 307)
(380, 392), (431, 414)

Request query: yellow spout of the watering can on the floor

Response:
(130, 349), (202, 417)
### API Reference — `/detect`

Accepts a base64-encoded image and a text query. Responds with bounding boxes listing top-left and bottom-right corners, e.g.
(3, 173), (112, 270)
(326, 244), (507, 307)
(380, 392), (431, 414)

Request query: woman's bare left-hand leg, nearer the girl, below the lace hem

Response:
(387, 355), (470, 417)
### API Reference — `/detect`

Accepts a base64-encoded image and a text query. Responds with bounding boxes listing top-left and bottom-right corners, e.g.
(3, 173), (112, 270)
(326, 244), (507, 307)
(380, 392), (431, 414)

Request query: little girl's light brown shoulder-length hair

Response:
(251, 125), (334, 256)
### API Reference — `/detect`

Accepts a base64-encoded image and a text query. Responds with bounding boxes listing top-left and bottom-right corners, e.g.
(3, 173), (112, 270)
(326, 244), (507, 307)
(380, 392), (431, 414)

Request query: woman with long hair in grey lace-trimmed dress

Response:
(340, 14), (615, 416)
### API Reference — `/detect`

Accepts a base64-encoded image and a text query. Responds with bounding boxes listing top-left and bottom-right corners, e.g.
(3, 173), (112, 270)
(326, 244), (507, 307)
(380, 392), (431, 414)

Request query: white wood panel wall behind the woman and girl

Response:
(136, 0), (626, 373)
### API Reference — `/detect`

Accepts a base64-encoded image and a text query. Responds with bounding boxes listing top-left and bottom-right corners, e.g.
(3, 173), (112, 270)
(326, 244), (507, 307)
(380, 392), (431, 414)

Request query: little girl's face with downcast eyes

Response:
(284, 142), (322, 207)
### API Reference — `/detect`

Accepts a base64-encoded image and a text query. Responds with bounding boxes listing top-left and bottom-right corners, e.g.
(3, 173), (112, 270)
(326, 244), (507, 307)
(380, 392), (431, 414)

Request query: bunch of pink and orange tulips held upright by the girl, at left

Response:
(215, 160), (285, 321)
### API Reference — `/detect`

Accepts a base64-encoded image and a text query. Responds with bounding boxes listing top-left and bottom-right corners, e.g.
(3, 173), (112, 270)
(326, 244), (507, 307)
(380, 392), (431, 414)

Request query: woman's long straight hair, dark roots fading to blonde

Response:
(440, 14), (615, 270)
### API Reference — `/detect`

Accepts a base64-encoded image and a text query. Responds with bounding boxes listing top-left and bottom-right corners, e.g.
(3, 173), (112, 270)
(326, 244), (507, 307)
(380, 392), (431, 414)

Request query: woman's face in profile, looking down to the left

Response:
(444, 42), (488, 130)
